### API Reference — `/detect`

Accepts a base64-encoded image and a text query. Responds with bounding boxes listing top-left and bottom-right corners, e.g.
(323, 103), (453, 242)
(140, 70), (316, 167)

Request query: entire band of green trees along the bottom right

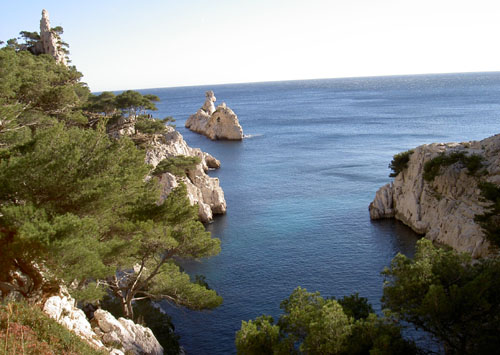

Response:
(236, 239), (500, 354)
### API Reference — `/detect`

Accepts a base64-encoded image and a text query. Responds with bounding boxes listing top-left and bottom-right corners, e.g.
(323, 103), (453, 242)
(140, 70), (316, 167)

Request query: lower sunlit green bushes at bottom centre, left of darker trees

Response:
(236, 287), (416, 354)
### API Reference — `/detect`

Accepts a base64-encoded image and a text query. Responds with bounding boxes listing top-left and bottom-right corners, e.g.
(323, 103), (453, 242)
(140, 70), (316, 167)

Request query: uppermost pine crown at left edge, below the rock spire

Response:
(0, 48), (89, 149)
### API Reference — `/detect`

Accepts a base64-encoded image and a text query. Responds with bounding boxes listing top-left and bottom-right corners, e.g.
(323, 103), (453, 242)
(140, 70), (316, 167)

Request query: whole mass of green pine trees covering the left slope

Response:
(0, 32), (222, 344)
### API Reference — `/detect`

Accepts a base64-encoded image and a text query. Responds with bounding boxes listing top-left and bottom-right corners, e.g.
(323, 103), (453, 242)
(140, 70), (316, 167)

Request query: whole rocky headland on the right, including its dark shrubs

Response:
(369, 135), (500, 257)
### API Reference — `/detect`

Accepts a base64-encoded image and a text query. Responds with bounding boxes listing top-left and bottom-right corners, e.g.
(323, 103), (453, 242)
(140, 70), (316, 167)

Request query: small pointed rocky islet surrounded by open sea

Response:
(185, 91), (243, 140)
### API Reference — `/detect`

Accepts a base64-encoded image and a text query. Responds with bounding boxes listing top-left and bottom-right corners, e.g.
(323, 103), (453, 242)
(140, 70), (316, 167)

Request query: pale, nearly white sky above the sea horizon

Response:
(0, 0), (500, 91)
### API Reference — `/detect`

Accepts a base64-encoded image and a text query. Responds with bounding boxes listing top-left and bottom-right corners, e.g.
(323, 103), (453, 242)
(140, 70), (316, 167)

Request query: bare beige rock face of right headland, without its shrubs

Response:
(369, 135), (500, 257)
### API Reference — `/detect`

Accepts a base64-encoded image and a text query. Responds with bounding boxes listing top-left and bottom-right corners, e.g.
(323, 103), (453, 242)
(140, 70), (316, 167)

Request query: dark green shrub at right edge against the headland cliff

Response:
(474, 182), (500, 247)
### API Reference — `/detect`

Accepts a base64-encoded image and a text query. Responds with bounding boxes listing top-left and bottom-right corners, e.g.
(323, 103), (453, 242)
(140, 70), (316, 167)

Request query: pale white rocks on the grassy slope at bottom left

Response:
(43, 289), (163, 355)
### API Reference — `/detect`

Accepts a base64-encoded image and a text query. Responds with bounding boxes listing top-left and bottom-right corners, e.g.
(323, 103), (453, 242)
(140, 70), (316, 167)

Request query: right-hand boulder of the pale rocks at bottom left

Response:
(94, 309), (163, 355)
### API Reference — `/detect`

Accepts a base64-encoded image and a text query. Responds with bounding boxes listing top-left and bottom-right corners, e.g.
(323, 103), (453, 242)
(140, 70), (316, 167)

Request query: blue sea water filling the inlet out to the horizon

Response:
(138, 73), (500, 354)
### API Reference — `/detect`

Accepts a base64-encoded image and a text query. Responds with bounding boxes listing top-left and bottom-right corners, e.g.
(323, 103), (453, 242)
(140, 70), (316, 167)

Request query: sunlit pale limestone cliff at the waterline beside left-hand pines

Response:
(146, 127), (226, 222)
